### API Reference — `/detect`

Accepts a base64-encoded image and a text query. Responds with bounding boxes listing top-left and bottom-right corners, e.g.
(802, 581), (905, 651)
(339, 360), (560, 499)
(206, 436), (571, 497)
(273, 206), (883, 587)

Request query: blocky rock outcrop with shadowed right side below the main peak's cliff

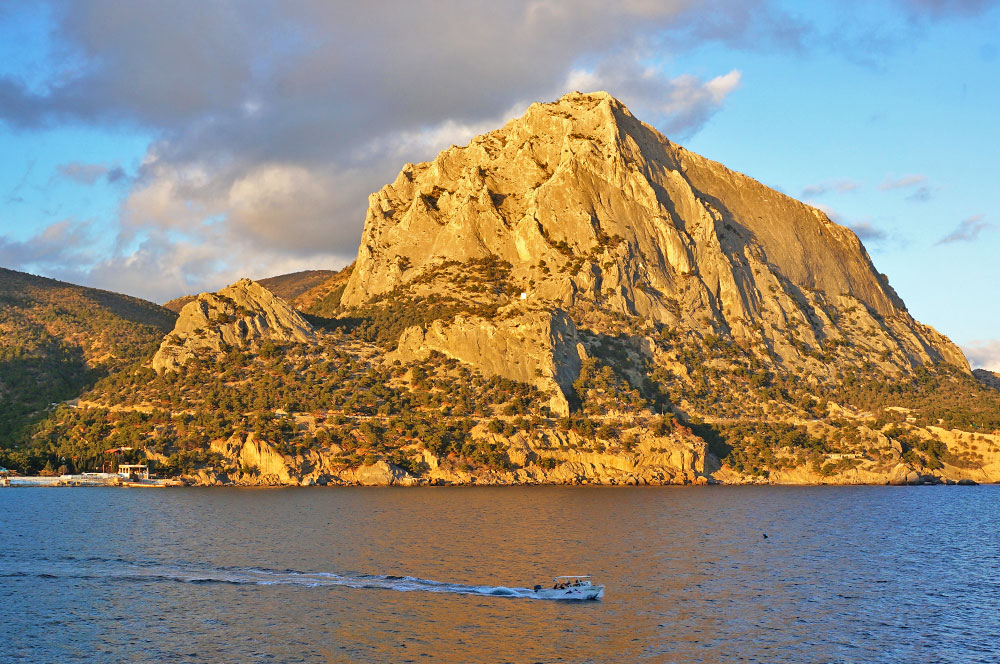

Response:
(392, 308), (580, 415)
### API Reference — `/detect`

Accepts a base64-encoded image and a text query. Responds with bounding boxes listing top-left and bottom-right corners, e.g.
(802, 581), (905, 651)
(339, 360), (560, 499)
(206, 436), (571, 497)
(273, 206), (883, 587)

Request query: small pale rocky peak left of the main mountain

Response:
(152, 279), (315, 371)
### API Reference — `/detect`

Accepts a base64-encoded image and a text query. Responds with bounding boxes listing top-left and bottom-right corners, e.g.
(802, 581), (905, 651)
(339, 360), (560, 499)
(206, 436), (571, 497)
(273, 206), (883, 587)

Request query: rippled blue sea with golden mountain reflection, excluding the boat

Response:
(0, 486), (1000, 663)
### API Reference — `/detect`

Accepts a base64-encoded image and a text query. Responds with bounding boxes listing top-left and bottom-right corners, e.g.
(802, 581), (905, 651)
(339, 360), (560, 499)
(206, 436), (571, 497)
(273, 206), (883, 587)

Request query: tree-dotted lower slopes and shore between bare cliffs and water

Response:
(3, 331), (1000, 486)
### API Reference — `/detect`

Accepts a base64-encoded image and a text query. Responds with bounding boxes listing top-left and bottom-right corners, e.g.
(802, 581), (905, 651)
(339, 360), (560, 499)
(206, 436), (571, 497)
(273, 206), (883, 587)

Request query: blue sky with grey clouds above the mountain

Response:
(0, 0), (1000, 371)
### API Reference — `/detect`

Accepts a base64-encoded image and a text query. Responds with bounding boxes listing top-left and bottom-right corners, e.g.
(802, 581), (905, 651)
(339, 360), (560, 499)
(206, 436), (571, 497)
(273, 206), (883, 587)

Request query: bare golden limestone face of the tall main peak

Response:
(342, 92), (968, 371)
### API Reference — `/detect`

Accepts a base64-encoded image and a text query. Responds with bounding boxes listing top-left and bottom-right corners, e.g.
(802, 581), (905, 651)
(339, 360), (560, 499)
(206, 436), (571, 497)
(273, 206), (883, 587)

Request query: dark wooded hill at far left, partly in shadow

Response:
(0, 268), (176, 454)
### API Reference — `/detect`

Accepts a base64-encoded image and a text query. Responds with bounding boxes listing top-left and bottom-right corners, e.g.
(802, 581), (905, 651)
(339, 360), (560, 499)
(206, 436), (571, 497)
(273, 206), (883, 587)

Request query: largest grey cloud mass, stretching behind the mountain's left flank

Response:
(0, 0), (984, 298)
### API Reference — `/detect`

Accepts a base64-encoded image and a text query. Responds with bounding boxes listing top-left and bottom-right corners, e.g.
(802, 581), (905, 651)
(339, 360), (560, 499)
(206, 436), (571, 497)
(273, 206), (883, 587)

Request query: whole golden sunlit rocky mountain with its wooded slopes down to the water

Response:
(0, 93), (1000, 485)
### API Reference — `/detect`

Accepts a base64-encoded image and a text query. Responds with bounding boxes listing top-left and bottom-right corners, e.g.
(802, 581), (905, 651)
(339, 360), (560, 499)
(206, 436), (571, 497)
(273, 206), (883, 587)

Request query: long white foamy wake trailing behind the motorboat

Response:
(0, 556), (564, 599)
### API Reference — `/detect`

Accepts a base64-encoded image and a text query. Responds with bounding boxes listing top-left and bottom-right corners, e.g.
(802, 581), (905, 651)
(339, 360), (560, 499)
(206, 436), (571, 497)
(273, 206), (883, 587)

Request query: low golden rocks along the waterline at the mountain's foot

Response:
(166, 431), (996, 487)
